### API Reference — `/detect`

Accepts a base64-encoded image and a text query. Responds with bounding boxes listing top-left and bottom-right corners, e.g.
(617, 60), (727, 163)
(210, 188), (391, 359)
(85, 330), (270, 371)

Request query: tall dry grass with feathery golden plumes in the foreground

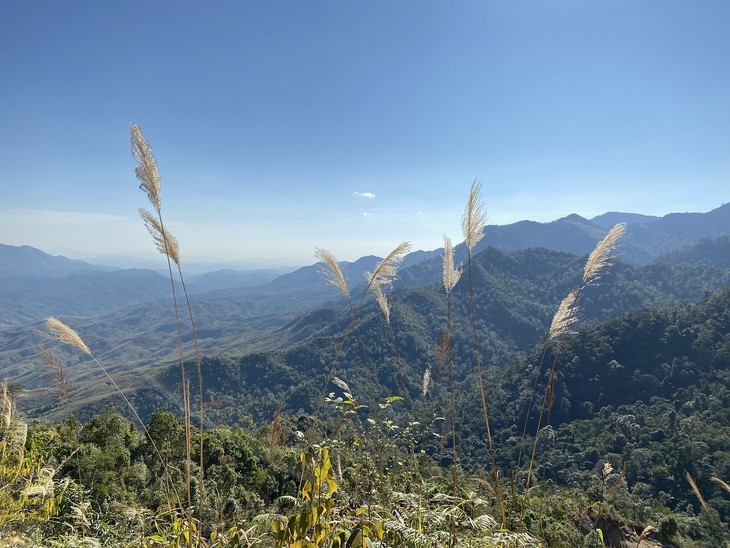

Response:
(0, 125), (730, 547)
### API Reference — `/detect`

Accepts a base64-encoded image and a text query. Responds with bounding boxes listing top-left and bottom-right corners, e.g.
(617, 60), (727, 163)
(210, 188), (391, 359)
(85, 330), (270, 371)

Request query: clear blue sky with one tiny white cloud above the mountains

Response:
(0, 0), (730, 264)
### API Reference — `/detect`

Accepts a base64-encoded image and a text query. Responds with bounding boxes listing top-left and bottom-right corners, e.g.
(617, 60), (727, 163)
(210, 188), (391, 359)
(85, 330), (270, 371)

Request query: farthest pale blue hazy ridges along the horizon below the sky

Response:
(0, 204), (730, 325)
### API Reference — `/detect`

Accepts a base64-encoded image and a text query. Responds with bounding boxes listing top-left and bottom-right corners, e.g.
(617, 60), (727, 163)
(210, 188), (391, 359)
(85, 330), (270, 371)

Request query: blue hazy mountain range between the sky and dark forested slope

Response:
(0, 204), (730, 420)
